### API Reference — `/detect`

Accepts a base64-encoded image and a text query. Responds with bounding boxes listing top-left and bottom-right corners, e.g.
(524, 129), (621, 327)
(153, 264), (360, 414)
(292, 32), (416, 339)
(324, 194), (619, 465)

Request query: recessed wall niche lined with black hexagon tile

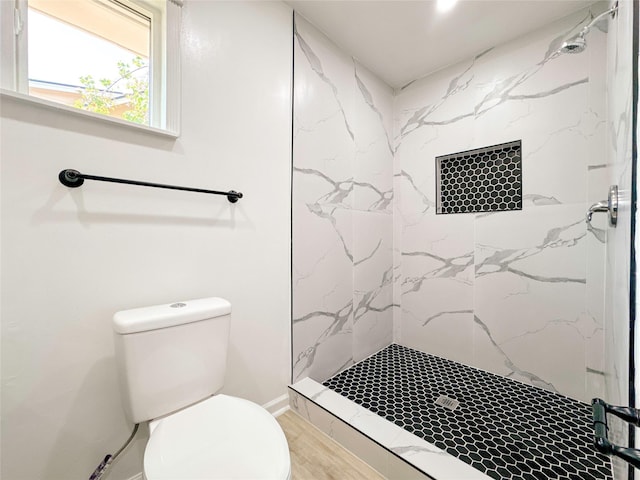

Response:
(436, 140), (522, 214)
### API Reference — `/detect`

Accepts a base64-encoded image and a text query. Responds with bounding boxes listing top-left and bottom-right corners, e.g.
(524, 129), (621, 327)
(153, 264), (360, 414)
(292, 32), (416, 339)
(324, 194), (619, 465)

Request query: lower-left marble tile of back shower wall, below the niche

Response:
(401, 214), (474, 364)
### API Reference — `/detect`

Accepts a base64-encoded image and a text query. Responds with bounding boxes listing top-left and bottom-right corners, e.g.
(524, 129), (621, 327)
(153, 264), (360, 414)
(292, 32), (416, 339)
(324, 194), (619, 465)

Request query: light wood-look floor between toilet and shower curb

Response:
(277, 410), (384, 480)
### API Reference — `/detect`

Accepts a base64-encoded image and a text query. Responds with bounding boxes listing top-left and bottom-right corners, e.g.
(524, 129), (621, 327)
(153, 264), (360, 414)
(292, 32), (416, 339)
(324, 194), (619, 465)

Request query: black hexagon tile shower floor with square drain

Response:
(324, 344), (613, 480)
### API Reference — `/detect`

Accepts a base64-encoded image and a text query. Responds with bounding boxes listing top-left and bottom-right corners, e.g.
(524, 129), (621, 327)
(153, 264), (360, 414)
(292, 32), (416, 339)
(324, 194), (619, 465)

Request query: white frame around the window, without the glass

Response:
(0, 0), (182, 138)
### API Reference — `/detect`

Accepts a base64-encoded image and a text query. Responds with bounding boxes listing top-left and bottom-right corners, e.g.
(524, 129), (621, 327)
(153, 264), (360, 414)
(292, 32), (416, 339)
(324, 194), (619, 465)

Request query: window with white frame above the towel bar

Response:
(0, 0), (180, 133)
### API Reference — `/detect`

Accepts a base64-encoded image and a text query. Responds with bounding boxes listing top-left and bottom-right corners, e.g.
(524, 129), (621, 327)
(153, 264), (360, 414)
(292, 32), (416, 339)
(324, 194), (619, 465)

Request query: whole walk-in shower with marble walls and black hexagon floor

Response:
(291, 2), (632, 480)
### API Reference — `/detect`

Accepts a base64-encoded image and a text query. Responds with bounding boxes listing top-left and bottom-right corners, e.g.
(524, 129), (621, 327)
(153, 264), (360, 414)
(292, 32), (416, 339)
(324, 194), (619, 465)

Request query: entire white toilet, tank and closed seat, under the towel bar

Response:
(113, 298), (291, 480)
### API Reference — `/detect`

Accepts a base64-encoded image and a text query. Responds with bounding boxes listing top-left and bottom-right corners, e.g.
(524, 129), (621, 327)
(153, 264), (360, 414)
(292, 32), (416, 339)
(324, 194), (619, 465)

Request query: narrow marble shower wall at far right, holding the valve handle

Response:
(604, 1), (639, 479)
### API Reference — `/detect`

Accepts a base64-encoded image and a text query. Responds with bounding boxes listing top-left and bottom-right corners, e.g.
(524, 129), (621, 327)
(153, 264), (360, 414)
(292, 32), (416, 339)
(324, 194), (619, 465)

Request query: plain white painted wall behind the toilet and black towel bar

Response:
(0, 1), (292, 480)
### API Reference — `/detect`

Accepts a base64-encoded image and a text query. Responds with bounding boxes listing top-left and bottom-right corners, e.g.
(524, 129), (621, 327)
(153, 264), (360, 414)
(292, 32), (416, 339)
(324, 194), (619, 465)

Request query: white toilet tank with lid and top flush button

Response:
(113, 297), (231, 423)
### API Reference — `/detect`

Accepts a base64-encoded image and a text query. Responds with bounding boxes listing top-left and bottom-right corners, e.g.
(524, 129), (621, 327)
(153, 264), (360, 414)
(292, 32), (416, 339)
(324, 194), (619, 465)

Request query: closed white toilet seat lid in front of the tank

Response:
(144, 395), (291, 480)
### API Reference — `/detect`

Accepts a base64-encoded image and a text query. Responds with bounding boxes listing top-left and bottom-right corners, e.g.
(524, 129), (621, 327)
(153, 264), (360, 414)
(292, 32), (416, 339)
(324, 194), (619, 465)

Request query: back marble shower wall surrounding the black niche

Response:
(394, 4), (608, 400)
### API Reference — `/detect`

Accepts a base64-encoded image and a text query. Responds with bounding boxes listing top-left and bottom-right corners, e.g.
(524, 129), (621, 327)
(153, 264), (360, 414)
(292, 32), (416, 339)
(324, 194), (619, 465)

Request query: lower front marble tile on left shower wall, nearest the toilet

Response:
(292, 200), (353, 378)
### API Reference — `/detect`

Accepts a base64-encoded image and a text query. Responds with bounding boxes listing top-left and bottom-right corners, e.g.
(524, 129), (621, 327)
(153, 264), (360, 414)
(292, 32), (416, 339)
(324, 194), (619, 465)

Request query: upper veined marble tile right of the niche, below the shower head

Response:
(474, 16), (589, 208)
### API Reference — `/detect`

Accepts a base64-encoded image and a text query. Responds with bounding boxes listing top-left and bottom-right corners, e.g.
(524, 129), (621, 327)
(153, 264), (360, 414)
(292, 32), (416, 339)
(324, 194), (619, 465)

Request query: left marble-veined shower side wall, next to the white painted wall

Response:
(292, 15), (393, 381)
